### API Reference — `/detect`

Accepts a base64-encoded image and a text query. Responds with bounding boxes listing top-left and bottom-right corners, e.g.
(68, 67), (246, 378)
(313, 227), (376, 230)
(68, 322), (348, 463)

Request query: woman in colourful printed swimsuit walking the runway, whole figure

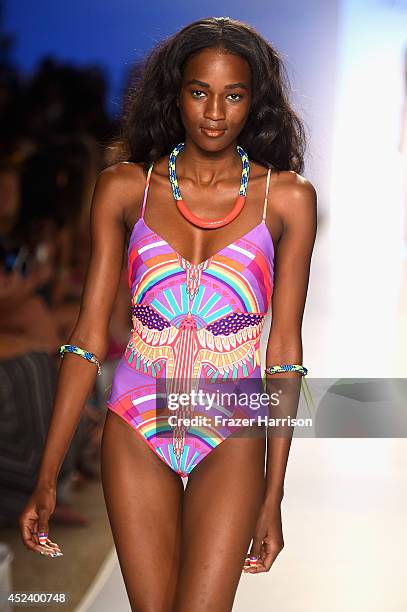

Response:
(20, 17), (317, 612)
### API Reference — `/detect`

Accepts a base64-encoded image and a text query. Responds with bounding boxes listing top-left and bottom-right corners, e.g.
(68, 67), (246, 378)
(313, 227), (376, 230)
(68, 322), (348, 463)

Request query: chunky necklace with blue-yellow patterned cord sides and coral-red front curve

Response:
(168, 142), (250, 229)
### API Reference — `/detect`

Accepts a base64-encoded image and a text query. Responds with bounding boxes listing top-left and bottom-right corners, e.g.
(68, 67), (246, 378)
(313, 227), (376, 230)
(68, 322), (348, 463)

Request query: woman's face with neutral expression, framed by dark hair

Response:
(178, 49), (251, 151)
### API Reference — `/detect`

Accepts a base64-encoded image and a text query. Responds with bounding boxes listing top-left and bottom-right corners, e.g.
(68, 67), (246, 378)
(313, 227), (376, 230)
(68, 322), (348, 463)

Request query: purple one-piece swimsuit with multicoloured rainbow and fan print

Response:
(107, 164), (274, 477)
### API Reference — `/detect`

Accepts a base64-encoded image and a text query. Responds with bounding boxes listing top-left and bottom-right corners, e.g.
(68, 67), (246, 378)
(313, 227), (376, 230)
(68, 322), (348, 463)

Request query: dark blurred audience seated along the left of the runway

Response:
(0, 57), (131, 525)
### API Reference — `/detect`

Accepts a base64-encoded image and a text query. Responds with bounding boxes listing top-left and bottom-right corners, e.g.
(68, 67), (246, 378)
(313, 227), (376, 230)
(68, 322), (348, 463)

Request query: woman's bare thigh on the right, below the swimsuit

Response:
(175, 437), (265, 612)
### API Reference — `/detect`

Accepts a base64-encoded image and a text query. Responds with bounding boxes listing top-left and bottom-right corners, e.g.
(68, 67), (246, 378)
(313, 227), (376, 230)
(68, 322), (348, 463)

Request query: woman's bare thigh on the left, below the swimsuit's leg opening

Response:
(101, 410), (184, 612)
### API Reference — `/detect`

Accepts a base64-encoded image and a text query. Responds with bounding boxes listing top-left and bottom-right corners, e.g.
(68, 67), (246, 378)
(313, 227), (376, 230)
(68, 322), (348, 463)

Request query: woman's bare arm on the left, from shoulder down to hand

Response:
(19, 164), (142, 552)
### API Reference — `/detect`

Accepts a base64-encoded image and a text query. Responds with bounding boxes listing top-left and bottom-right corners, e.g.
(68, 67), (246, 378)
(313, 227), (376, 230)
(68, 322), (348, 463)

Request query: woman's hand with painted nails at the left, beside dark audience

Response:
(18, 487), (63, 557)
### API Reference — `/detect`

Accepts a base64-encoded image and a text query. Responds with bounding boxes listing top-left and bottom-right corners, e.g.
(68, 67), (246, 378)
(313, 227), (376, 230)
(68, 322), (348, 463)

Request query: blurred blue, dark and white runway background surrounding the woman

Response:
(0, 0), (407, 612)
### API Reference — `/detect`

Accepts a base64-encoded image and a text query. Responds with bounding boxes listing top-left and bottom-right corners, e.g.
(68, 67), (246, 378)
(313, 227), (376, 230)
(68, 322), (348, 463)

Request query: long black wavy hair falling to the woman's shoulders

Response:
(118, 17), (305, 173)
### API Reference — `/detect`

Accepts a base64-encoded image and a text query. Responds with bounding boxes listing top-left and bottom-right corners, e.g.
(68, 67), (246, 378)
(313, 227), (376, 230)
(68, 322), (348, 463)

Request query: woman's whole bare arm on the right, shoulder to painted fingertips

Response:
(243, 172), (317, 574)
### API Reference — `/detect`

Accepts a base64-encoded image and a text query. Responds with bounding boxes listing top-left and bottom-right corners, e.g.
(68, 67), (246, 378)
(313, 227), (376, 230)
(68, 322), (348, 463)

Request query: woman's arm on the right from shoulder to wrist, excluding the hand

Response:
(265, 172), (317, 506)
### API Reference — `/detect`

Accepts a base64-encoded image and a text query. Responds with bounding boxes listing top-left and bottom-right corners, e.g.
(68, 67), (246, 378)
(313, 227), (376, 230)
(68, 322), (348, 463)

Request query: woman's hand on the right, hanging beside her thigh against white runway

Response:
(243, 503), (284, 574)
